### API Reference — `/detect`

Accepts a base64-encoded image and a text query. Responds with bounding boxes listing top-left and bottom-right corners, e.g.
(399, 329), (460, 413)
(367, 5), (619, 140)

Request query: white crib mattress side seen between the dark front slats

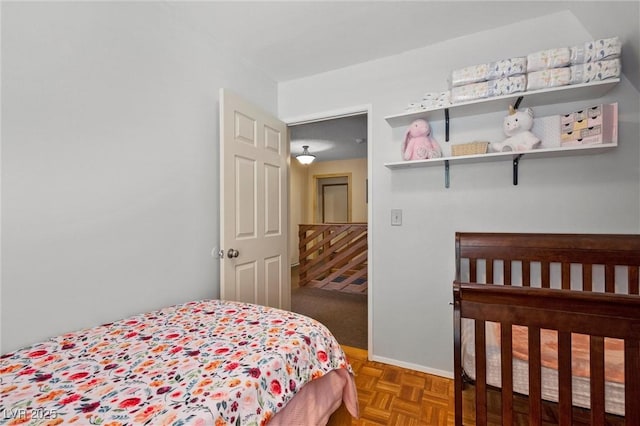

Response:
(461, 318), (624, 416)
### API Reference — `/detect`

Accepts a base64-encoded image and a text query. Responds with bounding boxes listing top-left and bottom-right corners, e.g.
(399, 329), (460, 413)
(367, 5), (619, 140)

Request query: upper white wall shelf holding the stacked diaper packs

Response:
(385, 78), (620, 127)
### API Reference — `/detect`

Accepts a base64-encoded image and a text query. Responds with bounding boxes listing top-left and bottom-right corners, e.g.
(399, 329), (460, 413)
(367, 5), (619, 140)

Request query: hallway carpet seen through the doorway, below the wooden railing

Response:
(291, 280), (367, 349)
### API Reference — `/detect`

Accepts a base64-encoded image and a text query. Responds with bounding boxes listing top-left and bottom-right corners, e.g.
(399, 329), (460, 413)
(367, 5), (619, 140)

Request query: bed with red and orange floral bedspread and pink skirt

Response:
(0, 300), (358, 426)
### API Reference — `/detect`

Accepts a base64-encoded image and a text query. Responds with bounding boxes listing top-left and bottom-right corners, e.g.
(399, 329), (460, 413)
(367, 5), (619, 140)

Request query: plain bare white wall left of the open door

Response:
(0, 2), (277, 353)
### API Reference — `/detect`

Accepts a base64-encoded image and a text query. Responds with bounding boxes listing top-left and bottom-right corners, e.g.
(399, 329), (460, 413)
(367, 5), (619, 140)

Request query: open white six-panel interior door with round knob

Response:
(220, 89), (291, 310)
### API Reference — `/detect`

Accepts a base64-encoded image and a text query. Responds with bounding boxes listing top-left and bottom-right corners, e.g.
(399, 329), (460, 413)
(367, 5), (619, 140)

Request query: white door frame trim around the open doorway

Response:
(280, 104), (375, 359)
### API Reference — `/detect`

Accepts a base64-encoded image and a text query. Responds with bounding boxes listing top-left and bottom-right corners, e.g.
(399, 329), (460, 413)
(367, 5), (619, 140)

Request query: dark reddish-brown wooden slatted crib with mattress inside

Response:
(453, 232), (640, 425)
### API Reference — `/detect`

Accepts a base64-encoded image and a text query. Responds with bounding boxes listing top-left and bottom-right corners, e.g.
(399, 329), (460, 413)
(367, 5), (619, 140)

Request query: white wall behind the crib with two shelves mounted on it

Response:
(278, 12), (640, 375)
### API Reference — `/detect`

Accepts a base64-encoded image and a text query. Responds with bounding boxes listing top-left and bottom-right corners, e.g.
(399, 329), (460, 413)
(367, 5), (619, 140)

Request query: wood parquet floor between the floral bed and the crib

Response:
(328, 346), (454, 426)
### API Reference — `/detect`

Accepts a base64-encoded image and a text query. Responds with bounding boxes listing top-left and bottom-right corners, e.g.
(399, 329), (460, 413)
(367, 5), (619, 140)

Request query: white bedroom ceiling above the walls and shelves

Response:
(161, 0), (640, 159)
